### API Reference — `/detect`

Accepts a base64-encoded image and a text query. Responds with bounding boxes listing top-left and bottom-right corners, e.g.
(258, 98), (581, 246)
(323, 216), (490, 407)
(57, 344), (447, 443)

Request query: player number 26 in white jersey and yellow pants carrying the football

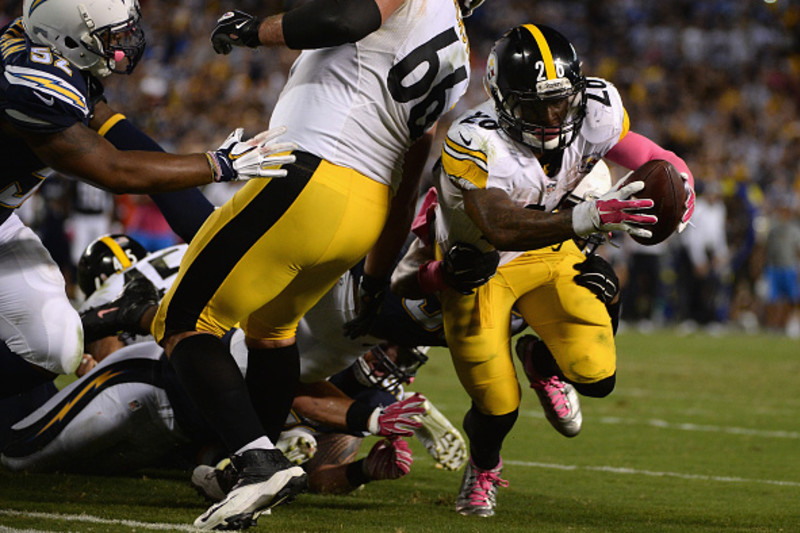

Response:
(424, 24), (694, 517)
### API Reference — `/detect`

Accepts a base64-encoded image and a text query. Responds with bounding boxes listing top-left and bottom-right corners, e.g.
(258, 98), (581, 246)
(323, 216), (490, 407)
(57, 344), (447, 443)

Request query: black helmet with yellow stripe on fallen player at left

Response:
(78, 234), (147, 298)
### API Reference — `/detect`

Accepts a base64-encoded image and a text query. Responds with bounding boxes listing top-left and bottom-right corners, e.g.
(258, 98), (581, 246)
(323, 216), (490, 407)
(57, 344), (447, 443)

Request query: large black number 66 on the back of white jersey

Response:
(388, 28), (467, 139)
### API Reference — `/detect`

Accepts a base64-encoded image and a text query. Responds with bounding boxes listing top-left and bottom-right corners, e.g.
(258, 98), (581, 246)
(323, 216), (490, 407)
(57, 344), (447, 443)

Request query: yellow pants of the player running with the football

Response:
(441, 241), (616, 415)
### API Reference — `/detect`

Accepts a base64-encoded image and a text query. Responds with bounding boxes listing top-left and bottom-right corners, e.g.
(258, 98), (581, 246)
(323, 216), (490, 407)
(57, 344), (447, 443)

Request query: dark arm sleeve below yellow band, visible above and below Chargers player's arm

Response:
(104, 119), (214, 242)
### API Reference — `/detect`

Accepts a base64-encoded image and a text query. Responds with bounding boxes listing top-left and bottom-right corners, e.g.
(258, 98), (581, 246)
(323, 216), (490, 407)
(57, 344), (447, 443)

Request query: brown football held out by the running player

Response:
(625, 159), (686, 246)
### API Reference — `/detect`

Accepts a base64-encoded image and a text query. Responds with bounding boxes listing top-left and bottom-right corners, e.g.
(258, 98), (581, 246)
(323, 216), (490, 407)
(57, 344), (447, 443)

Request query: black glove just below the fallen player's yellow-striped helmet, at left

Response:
(81, 277), (159, 344)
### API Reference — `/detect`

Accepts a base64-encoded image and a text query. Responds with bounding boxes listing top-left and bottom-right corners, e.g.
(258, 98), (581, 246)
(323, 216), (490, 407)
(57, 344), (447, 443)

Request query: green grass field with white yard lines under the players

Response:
(0, 331), (800, 533)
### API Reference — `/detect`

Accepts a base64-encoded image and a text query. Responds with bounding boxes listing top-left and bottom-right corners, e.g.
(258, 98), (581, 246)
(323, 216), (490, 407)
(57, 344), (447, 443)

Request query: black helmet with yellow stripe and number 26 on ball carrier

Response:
(484, 24), (586, 153)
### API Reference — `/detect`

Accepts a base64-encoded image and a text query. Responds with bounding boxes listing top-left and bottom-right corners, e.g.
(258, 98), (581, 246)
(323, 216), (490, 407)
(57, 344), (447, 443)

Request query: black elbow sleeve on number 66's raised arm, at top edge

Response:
(282, 0), (381, 50)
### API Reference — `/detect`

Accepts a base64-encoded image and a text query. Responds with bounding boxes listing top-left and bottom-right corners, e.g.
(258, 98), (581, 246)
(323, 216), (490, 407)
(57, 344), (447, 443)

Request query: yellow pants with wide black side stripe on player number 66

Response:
(152, 152), (391, 341)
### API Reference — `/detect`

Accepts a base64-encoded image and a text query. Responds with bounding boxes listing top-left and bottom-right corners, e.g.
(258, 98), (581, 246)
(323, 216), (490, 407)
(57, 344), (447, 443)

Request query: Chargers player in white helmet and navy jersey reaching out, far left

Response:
(0, 0), (294, 410)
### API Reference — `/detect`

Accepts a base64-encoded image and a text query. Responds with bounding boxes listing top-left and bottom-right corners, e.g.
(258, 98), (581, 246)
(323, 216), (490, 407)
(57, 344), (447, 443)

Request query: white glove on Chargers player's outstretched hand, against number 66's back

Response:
(206, 126), (297, 182)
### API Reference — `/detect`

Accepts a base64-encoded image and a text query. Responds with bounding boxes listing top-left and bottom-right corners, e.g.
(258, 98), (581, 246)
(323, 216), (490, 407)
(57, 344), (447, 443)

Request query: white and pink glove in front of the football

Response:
(572, 180), (658, 238)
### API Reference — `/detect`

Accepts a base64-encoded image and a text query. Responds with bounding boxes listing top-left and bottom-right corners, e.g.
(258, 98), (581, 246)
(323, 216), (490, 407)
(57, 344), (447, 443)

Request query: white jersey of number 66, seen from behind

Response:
(270, 0), (470, 190)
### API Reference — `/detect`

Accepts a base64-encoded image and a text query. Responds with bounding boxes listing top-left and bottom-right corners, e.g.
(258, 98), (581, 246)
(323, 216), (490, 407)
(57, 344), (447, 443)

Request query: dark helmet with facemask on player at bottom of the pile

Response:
(353, 343), (428, 394)
